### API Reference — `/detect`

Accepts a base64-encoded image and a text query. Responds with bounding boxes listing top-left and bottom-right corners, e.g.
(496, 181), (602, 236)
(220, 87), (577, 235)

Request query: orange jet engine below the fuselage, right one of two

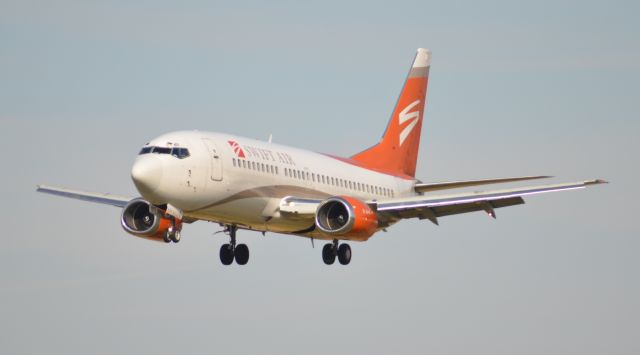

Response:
(316, 196), (378, 240)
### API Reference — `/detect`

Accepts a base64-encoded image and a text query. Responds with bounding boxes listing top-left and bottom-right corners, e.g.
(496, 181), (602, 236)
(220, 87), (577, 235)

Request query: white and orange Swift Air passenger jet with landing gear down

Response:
(37, 48), (607, 265)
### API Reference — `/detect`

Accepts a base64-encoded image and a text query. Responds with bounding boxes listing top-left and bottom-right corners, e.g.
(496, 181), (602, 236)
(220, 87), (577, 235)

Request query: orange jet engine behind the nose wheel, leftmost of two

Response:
(120, 199), (182, 241)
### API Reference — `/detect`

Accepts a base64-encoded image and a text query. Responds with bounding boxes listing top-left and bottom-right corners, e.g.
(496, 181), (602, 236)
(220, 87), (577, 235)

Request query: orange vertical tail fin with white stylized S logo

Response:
(351, 48), (431, 177)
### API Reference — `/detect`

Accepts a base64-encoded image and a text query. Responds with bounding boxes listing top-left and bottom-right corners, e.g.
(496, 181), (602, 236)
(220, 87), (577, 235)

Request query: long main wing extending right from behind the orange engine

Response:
(375, 179), (607, 224)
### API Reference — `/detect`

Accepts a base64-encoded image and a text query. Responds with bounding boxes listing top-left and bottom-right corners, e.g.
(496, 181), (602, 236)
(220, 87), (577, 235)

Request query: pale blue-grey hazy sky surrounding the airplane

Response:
(0, 0), (640, 355)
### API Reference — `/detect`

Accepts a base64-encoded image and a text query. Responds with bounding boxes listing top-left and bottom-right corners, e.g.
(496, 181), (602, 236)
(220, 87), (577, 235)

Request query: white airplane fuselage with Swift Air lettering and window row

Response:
(132, 131), (416, 239)
